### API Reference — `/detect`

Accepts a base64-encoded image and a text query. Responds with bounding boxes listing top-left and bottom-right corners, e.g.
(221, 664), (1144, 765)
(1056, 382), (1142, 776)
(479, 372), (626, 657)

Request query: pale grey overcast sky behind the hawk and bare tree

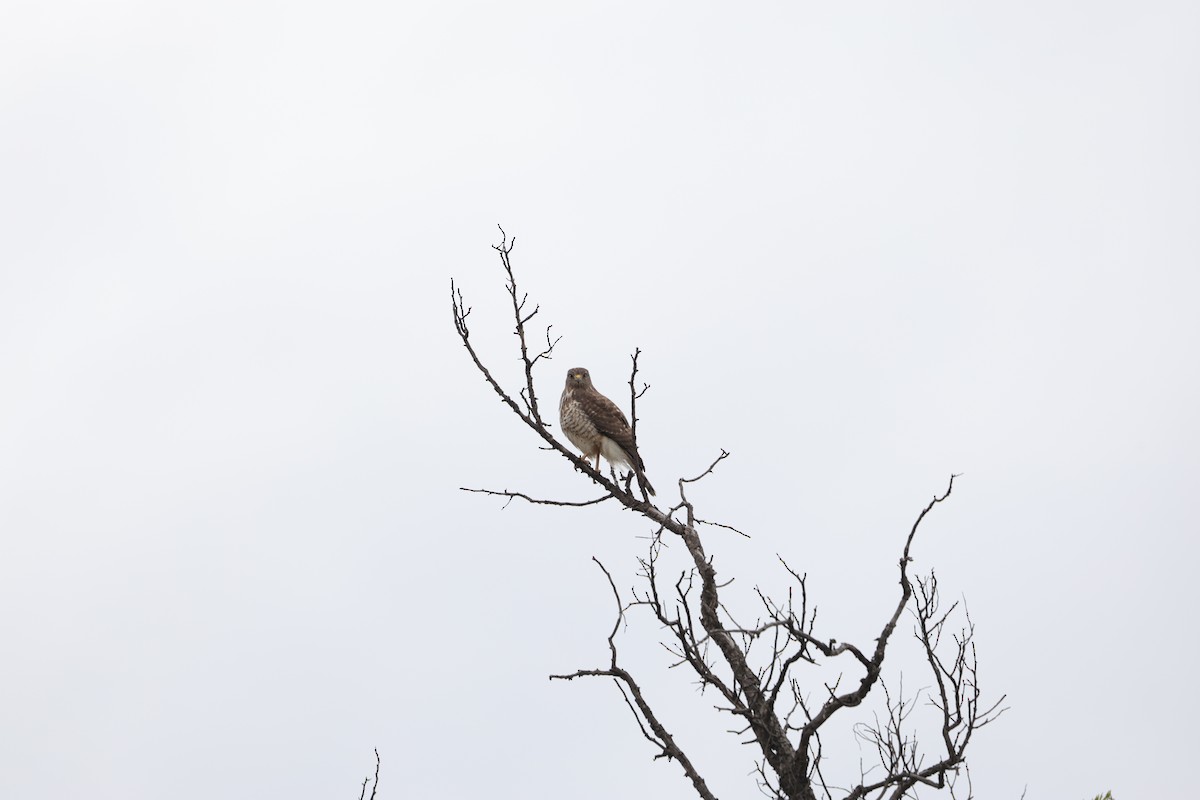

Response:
(0, 0), (1200, 800)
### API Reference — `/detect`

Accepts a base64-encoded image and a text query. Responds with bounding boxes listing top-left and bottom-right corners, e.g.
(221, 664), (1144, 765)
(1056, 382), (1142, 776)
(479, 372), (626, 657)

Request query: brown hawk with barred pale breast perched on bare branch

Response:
(558, 367), (654, 494)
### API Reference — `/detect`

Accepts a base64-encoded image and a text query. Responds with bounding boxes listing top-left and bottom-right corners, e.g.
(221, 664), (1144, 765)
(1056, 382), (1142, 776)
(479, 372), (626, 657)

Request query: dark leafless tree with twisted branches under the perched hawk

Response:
(450, 229), (1004, 800)
